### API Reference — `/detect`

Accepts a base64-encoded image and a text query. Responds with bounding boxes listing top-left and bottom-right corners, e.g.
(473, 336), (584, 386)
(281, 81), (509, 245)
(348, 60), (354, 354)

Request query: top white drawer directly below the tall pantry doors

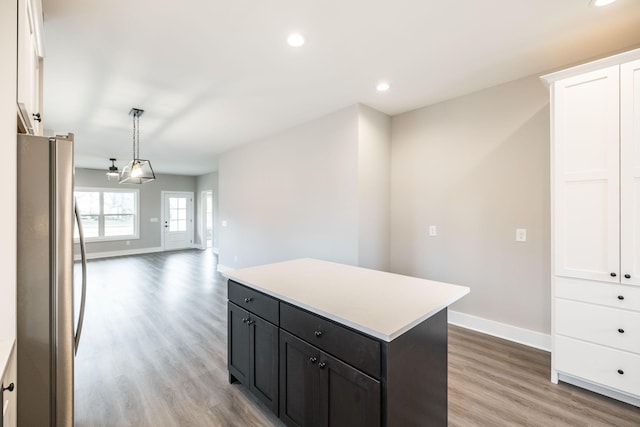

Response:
(554, 276), (640, 311)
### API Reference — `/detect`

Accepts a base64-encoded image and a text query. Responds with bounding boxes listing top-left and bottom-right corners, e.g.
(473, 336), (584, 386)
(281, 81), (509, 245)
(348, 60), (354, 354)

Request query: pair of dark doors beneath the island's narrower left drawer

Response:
(228, 285), (278, 413)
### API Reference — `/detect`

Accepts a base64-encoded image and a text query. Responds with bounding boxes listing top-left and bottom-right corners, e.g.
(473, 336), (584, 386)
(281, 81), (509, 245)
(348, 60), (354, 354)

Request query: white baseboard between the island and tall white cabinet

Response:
(449, 310), (551, 351)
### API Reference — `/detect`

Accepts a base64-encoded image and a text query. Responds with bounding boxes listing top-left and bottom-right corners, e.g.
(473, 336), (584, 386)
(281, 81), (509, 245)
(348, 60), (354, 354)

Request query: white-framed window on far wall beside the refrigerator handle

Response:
(74, 188), (139, 241)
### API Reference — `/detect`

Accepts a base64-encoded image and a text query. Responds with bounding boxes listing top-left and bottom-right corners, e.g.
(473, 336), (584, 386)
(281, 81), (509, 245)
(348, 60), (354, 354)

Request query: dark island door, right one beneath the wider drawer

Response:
(318, 354), (381, 427)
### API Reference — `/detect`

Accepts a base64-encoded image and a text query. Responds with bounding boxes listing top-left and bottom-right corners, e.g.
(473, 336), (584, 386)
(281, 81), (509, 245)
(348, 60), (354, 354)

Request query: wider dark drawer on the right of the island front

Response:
(280, 303), (380, 378)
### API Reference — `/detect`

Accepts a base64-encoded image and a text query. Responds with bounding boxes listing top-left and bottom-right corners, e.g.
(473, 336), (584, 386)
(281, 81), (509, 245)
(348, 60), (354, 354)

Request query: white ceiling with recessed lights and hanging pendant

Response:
(43, 0), (640, 175)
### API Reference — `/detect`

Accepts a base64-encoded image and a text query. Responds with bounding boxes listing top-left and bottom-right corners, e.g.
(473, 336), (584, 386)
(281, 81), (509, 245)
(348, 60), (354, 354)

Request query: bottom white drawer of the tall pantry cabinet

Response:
(553, 336), (640, 397)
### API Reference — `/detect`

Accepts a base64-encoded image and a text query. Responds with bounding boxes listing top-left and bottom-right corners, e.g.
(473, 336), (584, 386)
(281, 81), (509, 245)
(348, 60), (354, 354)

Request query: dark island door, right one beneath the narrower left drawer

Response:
(249, 315), (278, 414)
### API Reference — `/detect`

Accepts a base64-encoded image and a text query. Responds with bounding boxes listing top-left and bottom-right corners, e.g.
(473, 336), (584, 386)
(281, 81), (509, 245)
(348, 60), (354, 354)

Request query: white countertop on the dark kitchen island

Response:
(225, 258), (469, 341)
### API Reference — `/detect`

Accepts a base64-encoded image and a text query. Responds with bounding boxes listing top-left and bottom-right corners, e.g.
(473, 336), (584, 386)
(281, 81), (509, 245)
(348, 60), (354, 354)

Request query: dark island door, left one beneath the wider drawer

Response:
(280, 330), (321, 427)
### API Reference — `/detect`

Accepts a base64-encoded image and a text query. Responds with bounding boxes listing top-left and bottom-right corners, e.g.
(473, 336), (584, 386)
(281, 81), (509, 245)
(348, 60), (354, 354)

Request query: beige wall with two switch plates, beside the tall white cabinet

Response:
(391, 76), (551, 334)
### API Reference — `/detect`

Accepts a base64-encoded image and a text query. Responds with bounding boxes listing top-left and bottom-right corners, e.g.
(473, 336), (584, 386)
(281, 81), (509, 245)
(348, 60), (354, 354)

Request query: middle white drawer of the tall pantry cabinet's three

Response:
(555, 298), (640, 354)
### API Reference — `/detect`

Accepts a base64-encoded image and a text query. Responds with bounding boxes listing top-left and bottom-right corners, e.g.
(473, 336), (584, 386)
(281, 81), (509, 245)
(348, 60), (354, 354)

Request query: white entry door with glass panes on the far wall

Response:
(162, 191), (193, 251)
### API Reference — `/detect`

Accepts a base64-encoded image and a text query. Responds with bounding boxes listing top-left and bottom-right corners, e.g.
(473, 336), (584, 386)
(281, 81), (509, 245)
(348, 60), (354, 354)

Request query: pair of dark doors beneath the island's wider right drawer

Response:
(280, 330), (381, 427)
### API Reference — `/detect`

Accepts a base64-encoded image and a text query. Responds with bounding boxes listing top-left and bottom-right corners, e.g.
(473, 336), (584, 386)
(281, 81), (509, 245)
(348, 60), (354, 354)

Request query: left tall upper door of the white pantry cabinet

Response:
(552, 66), (620, 283)
